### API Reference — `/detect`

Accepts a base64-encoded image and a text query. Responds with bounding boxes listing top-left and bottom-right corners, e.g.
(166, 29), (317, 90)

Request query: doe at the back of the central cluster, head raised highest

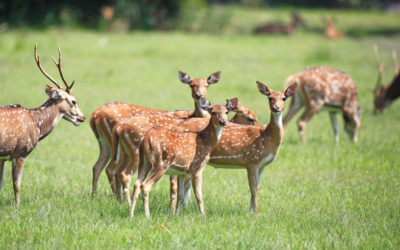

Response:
(90, 71), (221, 196)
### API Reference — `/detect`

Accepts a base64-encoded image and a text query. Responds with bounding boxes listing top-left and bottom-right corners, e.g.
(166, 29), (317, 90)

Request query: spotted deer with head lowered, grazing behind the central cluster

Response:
(283, 66), (361, 142)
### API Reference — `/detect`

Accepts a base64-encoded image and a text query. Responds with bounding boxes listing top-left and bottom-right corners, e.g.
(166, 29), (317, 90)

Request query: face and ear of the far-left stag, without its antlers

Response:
(46, 85), (85, 126)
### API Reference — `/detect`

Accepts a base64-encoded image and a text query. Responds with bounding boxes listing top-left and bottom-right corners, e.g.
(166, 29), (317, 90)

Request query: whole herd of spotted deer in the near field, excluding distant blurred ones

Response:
(0, 46), (400, 217)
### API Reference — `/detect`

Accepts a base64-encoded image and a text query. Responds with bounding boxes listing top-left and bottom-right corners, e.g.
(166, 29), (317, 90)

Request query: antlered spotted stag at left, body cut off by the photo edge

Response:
(0, 45), (85, 206)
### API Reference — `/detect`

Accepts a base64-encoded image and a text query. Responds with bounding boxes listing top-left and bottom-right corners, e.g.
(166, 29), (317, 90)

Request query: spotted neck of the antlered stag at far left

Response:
(29, 99), (63, 140)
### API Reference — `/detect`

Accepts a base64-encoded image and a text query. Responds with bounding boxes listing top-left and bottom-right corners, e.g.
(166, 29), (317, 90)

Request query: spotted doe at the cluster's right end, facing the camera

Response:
(173, 81), (297, 213)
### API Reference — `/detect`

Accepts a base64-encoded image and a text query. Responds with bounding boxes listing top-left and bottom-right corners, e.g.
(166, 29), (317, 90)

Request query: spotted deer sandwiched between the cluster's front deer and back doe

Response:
(107, 98), (241, 205)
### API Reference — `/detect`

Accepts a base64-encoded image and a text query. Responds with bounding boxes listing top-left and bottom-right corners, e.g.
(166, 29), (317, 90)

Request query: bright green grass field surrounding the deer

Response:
(0, 7), (400, 249)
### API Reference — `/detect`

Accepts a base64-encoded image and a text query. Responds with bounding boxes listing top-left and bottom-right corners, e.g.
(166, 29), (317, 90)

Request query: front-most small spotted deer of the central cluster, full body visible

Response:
(130, 98), (236, 218)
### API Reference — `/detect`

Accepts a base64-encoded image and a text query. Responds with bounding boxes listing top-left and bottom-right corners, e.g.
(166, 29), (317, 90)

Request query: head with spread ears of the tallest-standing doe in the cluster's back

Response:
(179, 71), (221, 100)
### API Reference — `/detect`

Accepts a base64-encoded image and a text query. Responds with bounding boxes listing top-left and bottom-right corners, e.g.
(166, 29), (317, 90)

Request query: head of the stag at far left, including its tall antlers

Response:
(34, 45), (85, 126)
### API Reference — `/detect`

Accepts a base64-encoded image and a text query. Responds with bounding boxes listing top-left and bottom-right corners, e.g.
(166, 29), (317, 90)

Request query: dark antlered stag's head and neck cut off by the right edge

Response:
(373, 45), (400, 114)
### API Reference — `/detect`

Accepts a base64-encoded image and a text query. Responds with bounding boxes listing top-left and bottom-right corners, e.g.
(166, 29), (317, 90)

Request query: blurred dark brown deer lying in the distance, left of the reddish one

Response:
(253, 12), (305, 35)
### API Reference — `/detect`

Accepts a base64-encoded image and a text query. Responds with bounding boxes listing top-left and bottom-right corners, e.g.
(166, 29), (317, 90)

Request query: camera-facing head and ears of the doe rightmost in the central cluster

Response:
(257, 81), (297, 114)
